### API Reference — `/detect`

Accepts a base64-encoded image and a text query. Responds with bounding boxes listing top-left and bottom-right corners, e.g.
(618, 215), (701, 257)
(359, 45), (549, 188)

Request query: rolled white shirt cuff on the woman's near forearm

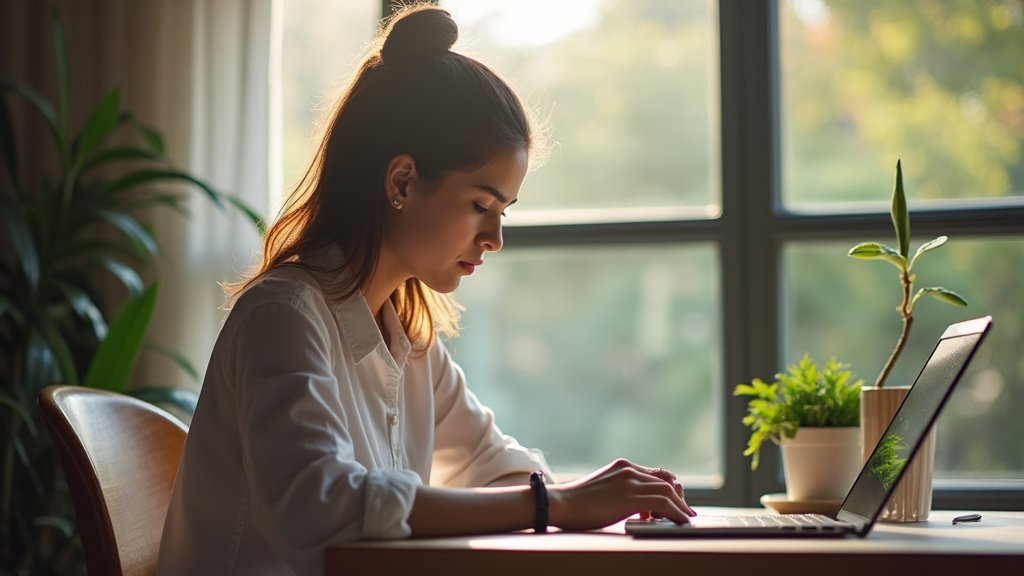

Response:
(362, 469), (422, 540)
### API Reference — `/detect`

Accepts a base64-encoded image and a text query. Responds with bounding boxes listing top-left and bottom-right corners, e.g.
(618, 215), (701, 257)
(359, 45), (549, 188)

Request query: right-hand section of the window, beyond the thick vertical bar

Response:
(778, 0), (1024, 485)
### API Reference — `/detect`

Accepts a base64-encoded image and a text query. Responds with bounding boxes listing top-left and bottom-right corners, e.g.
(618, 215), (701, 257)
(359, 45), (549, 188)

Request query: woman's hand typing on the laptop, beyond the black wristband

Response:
(548, 459), (696, 530)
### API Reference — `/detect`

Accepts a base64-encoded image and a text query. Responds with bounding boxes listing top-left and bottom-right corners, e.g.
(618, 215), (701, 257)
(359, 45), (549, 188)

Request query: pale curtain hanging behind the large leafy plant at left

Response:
(0, 0), (281, 389)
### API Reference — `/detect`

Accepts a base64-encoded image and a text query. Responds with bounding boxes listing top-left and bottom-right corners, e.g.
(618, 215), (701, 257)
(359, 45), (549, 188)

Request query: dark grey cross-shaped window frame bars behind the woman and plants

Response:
(381, 0), (1024, 509)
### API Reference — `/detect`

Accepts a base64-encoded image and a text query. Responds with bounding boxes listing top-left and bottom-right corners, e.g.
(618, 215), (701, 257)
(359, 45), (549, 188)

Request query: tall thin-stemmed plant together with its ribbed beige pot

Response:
(849, 156), (967, 522)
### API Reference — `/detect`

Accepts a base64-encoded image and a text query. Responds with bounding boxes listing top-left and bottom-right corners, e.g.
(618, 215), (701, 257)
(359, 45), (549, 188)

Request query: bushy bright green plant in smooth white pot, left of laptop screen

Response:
(733, 355), (864, 502)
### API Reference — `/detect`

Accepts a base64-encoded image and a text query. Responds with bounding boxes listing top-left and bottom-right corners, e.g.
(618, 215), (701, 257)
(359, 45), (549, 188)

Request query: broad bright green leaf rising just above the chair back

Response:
(85, 282), (160, 392)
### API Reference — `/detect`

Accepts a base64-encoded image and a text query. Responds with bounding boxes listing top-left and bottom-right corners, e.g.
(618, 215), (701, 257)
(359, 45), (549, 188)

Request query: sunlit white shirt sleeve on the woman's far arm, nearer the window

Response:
(429, 341), (550, 487)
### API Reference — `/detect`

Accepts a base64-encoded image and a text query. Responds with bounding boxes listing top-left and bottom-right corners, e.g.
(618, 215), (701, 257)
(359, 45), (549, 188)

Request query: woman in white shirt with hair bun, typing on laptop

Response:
(159, 5), (693, 575)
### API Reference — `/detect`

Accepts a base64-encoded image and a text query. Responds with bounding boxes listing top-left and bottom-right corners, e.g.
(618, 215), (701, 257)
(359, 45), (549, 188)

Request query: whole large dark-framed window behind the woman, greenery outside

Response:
(285, 0), (1024, 506)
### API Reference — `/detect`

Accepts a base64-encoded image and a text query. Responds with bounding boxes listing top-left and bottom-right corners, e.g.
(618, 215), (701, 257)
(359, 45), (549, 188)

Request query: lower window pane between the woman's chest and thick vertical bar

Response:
(449, 244), (724, 479)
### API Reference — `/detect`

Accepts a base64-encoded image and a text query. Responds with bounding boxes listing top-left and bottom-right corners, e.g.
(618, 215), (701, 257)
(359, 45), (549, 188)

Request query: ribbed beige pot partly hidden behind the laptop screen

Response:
(860, 386), (935, 522)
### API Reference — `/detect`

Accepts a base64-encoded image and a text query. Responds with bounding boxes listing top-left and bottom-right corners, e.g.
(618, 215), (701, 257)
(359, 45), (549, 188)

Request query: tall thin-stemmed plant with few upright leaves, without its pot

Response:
(849, 160), (967, 388)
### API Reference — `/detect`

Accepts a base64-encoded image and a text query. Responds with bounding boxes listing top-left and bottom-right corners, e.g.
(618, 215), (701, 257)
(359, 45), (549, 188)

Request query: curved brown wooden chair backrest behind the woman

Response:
(39, 385), (187, 576)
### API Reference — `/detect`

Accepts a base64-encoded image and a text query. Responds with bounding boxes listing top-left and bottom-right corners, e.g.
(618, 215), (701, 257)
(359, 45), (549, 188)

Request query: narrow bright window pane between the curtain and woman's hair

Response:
(272, 0), (381, 207)
